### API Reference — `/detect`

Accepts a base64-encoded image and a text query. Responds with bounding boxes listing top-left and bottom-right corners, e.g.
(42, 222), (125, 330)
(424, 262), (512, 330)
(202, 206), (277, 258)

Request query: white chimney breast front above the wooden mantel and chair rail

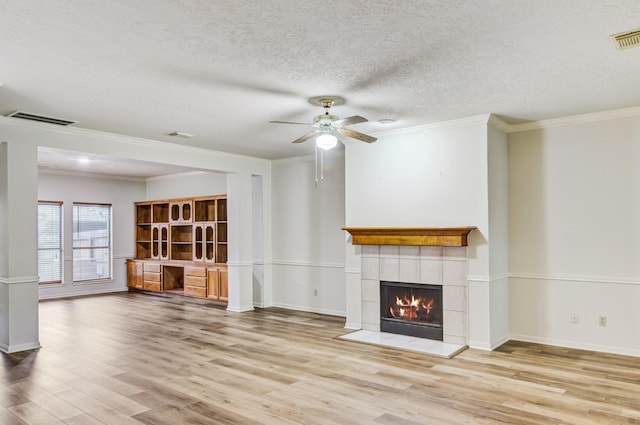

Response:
(346, 116), (489, 276)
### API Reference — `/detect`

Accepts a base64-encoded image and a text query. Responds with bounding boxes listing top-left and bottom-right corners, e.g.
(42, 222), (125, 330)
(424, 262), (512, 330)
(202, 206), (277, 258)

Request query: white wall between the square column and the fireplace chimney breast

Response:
(271, 150), (345, 316)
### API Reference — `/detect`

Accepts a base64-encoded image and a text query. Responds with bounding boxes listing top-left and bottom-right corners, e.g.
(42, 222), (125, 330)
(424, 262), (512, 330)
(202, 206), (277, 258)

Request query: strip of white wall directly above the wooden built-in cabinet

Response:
(145, 171), (227, 201)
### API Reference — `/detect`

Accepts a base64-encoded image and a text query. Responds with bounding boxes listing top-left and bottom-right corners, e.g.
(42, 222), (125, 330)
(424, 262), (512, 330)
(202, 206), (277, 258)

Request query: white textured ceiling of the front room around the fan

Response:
(0, 0), (640, 176)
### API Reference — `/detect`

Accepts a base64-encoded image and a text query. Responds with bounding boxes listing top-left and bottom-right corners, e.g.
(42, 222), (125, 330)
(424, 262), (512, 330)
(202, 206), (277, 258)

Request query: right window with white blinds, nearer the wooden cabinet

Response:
(73, 204), (112, 282)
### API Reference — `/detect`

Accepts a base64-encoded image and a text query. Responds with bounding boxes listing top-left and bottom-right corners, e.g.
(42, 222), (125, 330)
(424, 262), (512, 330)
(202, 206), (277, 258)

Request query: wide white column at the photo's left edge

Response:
(0, 142), (40, 353)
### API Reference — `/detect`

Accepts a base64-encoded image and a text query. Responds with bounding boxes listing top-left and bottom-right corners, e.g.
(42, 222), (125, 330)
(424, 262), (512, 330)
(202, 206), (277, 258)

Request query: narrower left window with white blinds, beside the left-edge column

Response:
(38, 201), (62, 283)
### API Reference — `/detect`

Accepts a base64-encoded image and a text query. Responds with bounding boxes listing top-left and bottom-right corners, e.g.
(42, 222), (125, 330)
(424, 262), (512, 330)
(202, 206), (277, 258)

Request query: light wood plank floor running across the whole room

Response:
(0, 293), (640, 425)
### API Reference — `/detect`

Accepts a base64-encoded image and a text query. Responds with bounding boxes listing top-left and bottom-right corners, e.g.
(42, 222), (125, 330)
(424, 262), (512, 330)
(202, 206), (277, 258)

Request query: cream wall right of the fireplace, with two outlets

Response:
(508, 117), (640, 355)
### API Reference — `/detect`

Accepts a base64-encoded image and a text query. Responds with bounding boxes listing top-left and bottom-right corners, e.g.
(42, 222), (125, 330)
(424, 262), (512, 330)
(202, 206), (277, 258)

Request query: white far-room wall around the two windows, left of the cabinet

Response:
(38, 172), (146, 299)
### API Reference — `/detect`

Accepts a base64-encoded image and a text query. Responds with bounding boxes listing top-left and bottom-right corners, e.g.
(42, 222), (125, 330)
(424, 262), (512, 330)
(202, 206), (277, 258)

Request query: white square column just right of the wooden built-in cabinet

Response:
(227, 173), (253, 312)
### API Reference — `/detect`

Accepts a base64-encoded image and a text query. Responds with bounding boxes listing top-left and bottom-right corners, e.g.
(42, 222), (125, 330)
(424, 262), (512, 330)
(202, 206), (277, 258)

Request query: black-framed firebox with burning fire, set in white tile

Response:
(380, 281), (443, 341)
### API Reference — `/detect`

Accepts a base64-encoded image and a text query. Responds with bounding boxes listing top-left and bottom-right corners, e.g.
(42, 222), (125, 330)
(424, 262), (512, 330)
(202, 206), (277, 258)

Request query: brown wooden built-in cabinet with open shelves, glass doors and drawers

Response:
(127, 195), (228, 301)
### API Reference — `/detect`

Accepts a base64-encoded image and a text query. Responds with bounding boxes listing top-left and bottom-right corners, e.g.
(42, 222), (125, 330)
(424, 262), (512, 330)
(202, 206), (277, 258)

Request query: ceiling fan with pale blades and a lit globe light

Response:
(269, 97), (378, 149)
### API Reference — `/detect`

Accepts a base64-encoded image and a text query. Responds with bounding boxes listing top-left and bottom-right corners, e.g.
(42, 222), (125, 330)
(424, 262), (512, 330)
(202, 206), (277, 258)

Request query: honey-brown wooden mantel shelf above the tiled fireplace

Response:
(342, 227), (475, 246)
